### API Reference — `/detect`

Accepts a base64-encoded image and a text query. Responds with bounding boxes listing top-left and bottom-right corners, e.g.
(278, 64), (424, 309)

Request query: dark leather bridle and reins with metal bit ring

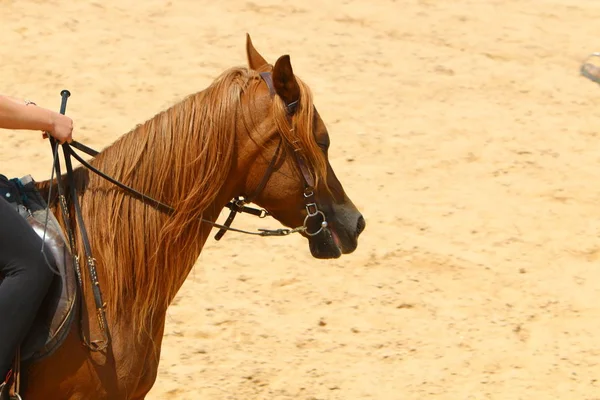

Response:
(48, 72), (328, 351)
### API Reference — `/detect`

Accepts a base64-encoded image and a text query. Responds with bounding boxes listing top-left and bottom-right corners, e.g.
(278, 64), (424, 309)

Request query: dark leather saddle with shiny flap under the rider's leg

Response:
(0, 175), (78, 400)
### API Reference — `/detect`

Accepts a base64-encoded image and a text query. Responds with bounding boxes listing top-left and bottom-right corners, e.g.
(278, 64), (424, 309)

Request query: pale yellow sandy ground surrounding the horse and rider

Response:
(0, 0), (600, 400)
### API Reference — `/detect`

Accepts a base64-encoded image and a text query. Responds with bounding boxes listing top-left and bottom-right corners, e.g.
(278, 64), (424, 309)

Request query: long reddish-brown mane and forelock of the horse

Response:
(54, 68), (327, 335)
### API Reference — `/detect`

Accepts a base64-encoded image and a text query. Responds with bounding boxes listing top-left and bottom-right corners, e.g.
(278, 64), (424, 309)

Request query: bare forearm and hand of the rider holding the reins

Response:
(0, 95), (73, 143)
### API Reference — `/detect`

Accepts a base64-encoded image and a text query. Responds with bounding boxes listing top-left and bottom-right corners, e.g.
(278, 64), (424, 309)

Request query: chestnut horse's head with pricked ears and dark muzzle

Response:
(240, 36), (365, 258)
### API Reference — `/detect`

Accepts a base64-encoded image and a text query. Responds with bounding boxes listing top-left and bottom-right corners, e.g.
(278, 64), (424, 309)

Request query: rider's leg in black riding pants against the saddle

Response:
(0, 197), (53, 383)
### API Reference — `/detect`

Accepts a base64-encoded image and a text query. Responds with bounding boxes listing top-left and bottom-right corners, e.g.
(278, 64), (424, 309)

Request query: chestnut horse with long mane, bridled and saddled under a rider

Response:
(21, 36), (365, 400)
